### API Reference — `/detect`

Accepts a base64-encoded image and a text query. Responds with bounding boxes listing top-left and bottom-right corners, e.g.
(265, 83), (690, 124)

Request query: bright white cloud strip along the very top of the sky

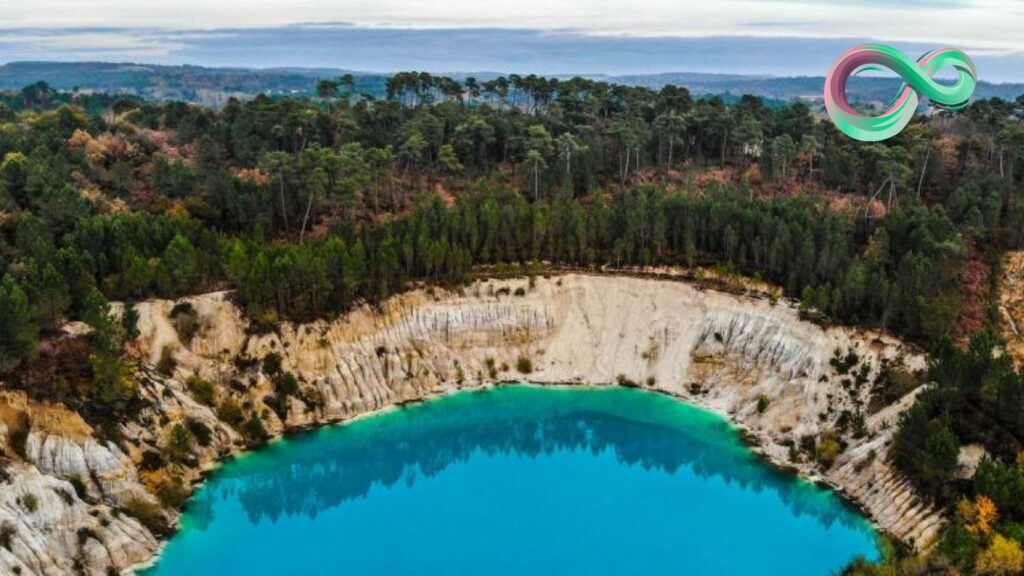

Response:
(0, 0), (1024, 49)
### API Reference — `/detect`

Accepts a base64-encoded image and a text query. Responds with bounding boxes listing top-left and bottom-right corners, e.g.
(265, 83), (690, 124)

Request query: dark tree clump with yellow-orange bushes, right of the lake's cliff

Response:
(848, 333), (1024, 574)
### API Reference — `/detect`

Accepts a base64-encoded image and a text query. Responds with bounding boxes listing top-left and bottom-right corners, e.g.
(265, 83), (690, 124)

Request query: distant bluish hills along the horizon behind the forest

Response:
(0, 61), (1024, 107)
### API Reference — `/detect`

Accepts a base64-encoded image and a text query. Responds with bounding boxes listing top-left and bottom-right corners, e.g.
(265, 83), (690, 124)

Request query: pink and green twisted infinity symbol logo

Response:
(825, 44), (977, 142)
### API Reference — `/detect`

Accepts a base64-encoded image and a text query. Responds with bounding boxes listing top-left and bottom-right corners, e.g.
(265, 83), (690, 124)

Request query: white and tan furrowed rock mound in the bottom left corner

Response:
(0, 392), (158, 575)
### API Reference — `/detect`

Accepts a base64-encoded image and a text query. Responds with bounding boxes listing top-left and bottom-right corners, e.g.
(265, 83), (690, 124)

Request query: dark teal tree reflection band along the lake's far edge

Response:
(188, 386), (865, 529)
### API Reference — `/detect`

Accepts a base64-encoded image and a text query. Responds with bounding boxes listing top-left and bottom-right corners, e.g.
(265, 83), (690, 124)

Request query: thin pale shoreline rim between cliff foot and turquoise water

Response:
(121, 378), (880, 576)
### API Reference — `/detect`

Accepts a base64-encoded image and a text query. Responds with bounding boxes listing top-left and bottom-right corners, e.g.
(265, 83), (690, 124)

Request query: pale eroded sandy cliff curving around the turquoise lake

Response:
(0, 275), (942, 574)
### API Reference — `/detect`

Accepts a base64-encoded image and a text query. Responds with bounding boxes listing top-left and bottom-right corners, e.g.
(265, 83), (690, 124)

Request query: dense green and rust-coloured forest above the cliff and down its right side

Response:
(0, 73), (1024, 572)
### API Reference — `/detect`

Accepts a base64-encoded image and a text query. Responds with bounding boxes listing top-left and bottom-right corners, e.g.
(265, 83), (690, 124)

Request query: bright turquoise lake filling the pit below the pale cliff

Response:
(142, 385), (879, 576)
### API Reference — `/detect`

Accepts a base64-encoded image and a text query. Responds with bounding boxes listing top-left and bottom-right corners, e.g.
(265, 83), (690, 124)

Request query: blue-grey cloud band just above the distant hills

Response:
(0, 10), (1024, 82)
